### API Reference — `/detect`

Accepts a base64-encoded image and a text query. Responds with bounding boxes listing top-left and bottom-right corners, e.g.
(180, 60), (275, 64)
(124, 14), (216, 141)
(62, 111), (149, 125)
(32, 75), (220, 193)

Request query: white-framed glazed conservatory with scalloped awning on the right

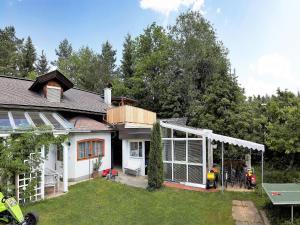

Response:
(160, 120), (265, 190)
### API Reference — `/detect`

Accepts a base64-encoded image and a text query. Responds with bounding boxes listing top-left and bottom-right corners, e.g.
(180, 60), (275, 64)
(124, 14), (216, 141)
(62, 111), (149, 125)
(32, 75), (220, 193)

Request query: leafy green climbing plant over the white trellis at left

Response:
(0, 127), (66, 199)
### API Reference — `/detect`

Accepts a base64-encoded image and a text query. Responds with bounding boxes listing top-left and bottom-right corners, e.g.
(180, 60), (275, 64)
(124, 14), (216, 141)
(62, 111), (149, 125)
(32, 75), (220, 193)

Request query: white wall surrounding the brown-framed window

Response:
(69, 132), (111, 180)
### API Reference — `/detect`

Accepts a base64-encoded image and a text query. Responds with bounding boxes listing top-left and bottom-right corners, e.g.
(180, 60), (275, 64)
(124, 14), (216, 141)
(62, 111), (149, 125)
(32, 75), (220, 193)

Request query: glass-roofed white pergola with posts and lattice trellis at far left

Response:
(0, 110), (74, 203)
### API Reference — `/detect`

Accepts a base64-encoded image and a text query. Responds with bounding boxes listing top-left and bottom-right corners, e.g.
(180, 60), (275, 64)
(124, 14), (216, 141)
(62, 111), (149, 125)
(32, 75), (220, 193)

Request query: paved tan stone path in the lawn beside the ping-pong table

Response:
(232, 200), (269, 225)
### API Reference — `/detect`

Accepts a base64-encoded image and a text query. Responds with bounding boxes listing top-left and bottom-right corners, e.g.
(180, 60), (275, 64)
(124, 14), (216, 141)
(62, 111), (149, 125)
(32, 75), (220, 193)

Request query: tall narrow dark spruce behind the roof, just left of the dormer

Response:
(21, 36), (36, 77)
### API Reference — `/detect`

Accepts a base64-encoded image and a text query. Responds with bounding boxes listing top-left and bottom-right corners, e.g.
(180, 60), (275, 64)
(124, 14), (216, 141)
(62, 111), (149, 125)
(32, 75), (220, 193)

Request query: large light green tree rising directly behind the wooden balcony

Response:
(132, 23), (172, 112)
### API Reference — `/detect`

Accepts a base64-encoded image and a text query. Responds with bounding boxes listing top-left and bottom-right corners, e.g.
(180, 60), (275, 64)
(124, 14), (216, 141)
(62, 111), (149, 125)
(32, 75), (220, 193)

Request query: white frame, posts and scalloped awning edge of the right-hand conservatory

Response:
(160, 120), (265, 191)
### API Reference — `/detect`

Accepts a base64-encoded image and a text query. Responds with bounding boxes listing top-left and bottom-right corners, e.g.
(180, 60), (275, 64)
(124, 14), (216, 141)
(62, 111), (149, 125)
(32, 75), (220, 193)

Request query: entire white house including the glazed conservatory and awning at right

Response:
(0, 70), (264, 202)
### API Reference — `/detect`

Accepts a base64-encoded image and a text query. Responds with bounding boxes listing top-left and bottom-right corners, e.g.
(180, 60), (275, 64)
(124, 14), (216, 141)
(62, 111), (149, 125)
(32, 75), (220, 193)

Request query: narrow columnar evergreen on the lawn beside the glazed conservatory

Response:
(148, 122), (163, 189)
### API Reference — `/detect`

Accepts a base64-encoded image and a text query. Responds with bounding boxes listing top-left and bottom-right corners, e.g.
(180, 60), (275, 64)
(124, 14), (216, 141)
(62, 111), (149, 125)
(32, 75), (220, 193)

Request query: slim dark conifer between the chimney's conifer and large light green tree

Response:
(121, 34), (134, 81)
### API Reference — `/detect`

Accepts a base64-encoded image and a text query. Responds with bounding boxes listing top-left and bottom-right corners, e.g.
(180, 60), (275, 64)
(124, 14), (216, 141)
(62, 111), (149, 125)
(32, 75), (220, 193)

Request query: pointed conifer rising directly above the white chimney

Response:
(100, 41), (116, 89)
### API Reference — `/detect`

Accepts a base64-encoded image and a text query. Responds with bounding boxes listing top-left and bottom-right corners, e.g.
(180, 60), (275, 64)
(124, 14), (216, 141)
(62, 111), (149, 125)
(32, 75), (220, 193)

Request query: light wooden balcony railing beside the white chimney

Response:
(107, 105), (156, 126)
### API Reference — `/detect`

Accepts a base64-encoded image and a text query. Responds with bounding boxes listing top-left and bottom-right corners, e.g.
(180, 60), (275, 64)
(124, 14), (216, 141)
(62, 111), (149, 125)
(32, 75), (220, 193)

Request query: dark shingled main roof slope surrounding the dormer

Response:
(0, 76), (108, 114)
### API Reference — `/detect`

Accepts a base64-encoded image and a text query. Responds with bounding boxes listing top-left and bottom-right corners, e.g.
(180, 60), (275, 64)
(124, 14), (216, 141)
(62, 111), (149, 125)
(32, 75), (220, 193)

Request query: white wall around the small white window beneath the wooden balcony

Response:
(122, 139), (148, 176)
